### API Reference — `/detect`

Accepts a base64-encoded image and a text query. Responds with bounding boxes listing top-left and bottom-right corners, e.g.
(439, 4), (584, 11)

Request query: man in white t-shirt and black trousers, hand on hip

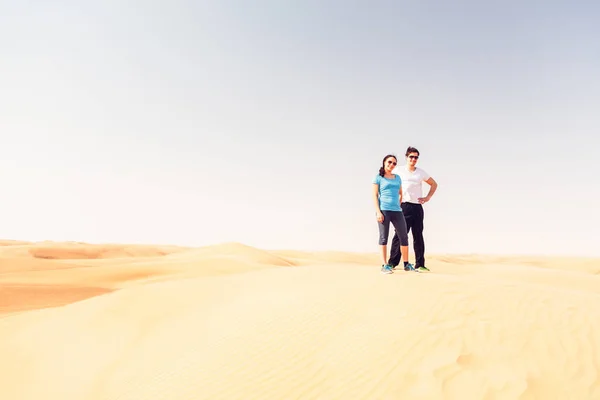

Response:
(388, 147), (438, 272)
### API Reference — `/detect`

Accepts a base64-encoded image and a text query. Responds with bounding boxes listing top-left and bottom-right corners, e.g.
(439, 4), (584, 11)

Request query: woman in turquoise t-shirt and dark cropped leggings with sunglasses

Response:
(373, 154), (415, 274)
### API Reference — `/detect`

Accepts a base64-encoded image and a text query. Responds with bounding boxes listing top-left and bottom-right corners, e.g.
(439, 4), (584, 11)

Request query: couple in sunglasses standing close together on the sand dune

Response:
(373, 147), (437, 274)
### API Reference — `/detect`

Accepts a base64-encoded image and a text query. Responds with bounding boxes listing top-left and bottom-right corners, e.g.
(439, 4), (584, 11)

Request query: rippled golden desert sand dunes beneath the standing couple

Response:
(0, 241), (600, 400)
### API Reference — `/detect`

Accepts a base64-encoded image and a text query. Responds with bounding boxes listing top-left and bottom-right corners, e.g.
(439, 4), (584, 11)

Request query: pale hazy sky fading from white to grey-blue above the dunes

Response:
(0, 0), (600, 256)
